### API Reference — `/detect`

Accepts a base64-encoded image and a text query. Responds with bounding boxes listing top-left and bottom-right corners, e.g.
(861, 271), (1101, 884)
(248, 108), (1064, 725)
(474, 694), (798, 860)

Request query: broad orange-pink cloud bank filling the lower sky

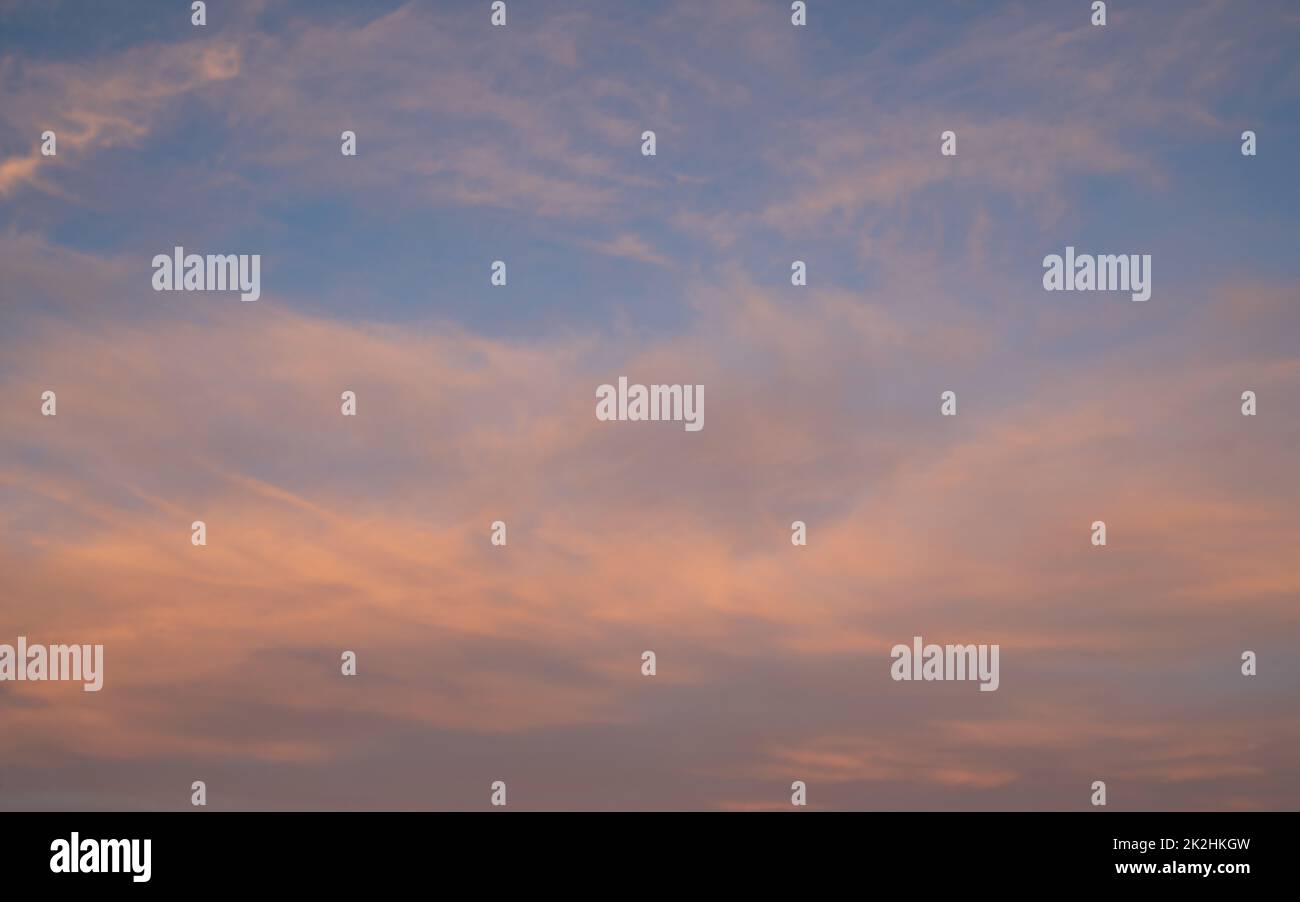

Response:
(0, 222), (1300, 807)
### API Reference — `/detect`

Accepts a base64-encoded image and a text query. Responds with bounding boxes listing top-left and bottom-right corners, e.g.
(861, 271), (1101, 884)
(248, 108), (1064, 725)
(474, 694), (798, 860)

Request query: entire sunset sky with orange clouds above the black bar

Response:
(0, 0), (1300, 811)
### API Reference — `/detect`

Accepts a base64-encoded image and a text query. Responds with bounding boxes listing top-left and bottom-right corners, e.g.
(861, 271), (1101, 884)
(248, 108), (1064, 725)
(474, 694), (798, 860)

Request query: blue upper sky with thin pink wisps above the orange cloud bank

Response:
(0, 3), (1300, 335)
